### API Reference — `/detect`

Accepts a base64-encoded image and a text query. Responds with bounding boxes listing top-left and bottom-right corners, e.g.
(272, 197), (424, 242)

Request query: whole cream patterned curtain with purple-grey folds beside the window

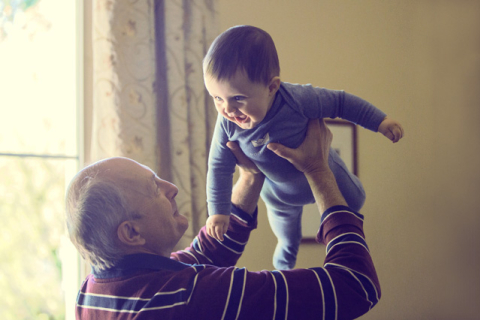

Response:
(85, 0), (218, 247)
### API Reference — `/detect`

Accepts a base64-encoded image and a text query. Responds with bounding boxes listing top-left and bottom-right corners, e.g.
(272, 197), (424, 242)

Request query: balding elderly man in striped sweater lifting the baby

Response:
(67, 120), (380, 320)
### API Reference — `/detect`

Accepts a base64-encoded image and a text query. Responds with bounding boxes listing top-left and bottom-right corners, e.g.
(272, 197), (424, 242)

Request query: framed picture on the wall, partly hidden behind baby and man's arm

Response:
(302, 119), (358, 243)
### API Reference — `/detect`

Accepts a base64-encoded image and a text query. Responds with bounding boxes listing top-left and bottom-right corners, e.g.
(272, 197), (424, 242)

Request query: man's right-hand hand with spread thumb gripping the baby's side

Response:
(267, 119), (333, 174)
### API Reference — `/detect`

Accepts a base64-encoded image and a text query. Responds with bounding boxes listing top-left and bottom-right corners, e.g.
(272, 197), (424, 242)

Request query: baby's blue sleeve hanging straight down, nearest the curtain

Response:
(207, 115), (236, 216)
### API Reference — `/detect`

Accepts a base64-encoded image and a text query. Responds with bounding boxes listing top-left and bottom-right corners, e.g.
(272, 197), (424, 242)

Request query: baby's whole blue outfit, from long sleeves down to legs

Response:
(207, 82), (386, 269)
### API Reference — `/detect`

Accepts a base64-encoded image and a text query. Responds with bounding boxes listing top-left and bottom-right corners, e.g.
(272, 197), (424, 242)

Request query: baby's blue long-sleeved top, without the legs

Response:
(207, 82), (386, 215)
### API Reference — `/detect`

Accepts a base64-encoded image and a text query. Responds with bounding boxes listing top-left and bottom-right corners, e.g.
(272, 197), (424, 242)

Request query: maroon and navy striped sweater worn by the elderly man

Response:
(76, 206), (380, 320)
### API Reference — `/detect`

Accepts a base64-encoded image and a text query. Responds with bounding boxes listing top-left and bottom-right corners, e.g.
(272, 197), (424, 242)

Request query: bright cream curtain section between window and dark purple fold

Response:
(91, 0), (156, 168)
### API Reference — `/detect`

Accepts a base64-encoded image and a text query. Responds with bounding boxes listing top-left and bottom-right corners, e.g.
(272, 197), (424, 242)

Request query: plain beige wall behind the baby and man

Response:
(218, 0), (480, 319)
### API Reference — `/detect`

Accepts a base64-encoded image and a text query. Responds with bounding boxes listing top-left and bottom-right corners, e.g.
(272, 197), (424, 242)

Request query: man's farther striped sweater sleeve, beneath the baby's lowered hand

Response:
(171, 205), (257, 267)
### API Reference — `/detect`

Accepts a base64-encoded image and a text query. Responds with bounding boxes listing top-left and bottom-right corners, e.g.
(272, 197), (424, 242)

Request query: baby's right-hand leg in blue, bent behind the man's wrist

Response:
(328, 148), (365, 211)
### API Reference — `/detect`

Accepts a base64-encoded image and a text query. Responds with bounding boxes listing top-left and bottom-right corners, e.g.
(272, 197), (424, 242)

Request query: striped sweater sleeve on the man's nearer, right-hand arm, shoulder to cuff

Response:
(185, 206), (381, 320)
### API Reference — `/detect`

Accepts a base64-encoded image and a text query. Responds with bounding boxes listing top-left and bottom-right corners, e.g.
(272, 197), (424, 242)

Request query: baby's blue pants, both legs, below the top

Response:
(261, 149), (365, 270)
